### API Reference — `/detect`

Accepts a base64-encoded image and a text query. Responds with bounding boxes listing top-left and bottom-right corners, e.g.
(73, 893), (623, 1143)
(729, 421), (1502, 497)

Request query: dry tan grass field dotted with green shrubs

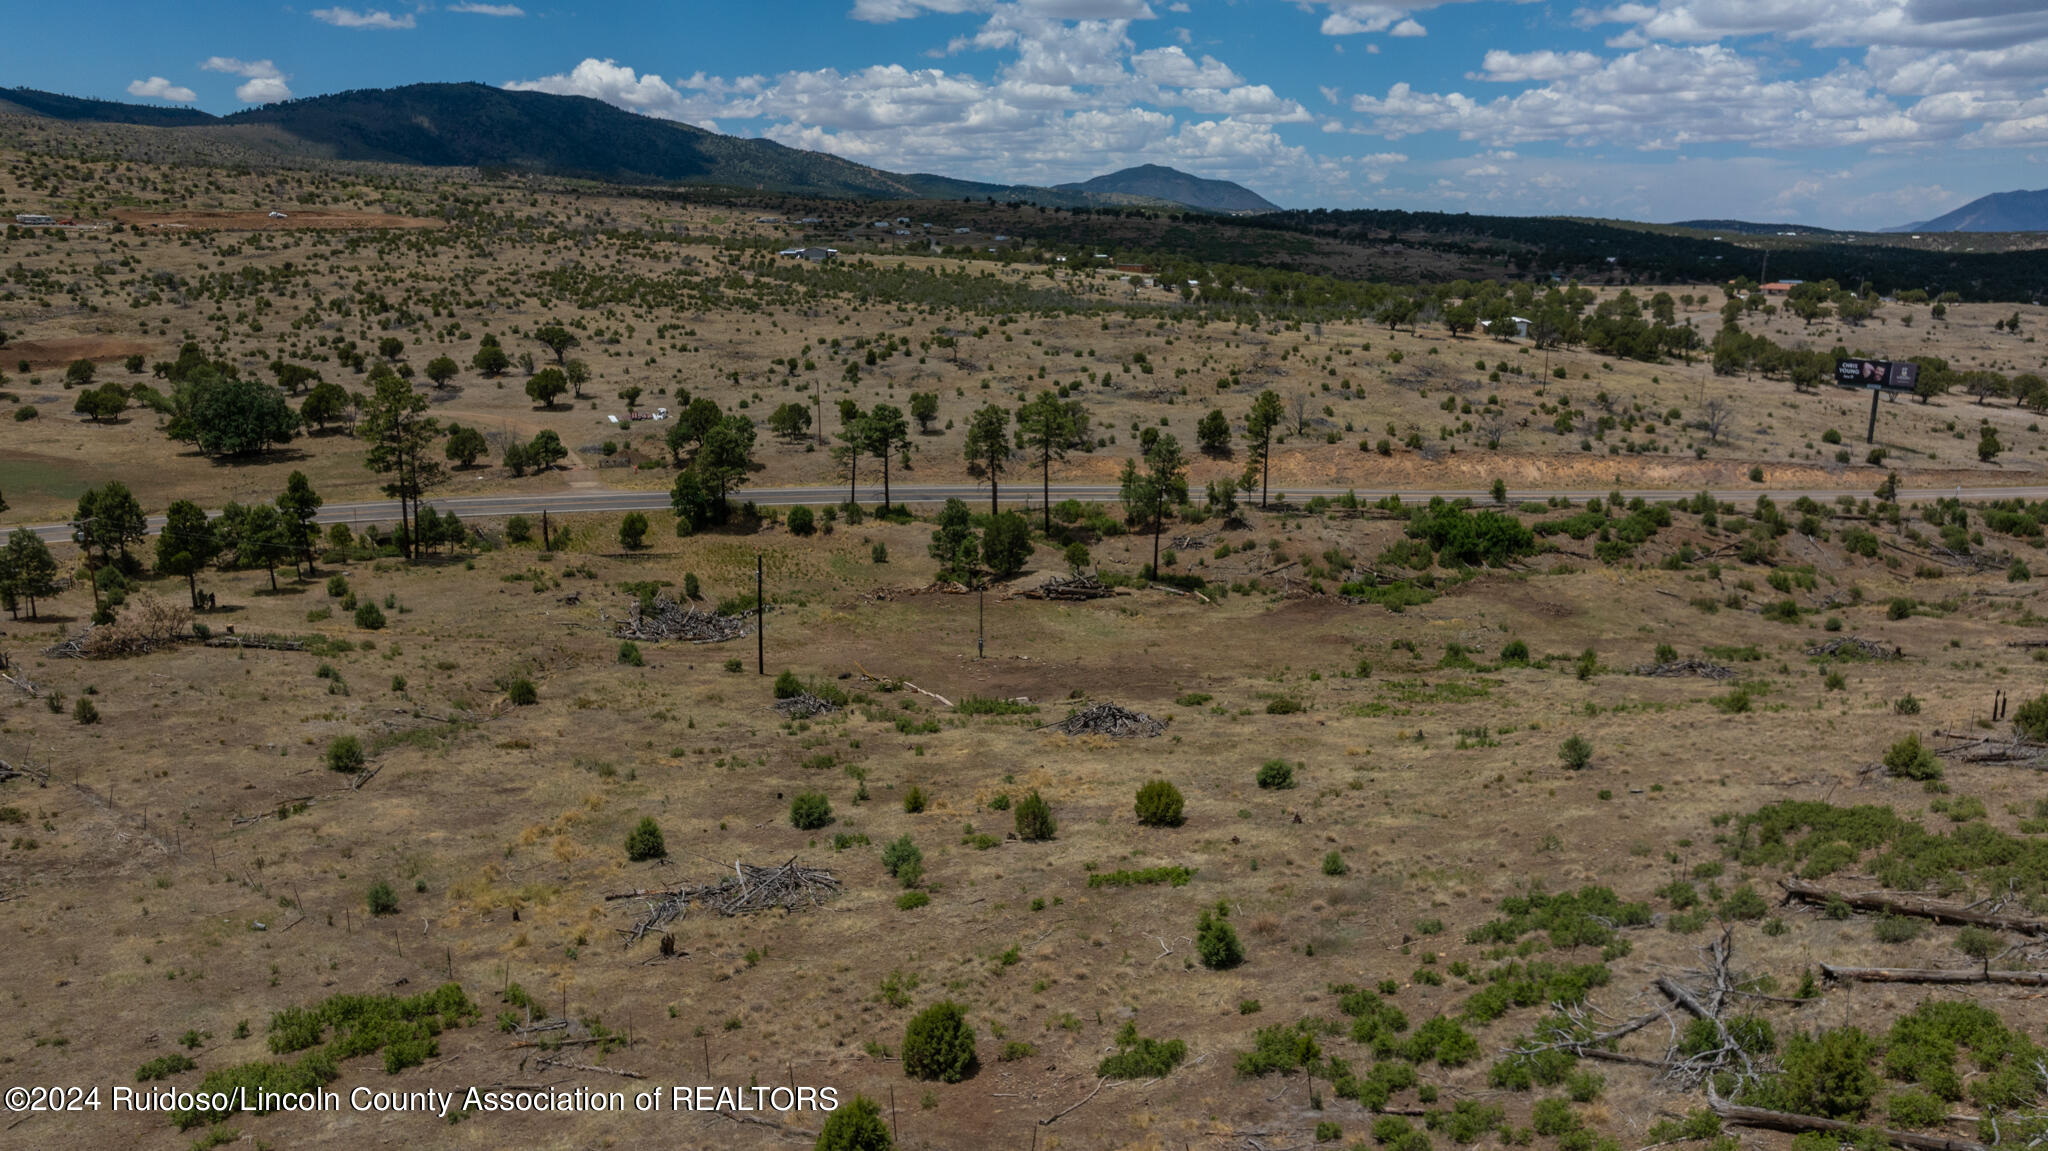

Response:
(0, 116), (2048, 1151)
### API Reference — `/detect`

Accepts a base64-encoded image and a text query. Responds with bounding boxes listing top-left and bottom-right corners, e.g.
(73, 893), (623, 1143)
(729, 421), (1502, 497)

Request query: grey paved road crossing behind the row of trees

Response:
(16, 477), (2048, 543)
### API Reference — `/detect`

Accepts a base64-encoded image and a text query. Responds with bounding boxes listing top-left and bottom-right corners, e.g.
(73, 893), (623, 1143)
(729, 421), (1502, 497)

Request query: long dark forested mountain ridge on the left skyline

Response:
(0, 84), (1276, 213)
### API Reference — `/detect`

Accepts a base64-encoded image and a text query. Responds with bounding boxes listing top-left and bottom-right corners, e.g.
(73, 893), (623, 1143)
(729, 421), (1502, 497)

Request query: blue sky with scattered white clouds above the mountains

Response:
(0, 0), (2048, 227)
